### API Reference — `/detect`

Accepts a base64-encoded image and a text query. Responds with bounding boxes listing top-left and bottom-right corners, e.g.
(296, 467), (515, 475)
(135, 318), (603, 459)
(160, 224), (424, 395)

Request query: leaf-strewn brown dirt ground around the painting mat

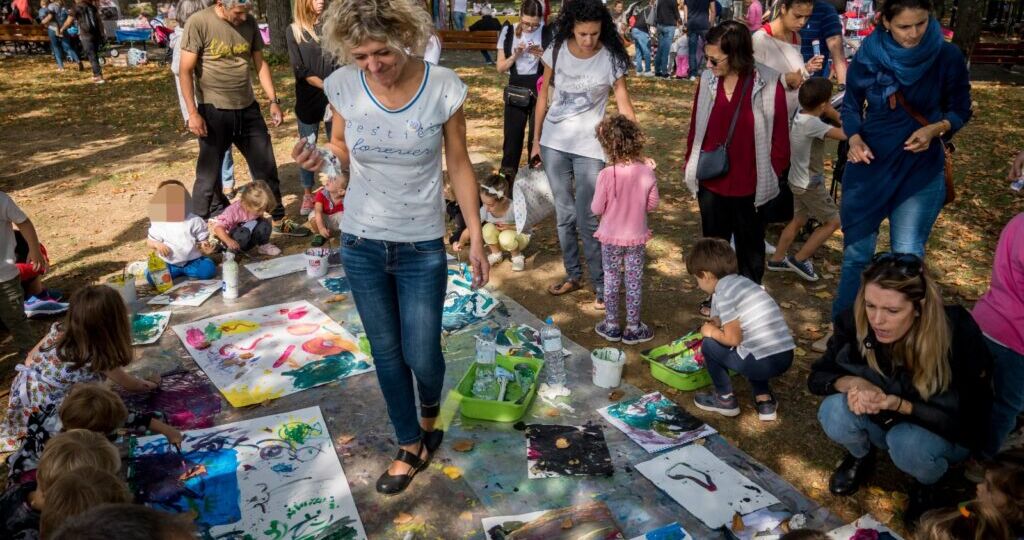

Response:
(0, 50), (1024, 528)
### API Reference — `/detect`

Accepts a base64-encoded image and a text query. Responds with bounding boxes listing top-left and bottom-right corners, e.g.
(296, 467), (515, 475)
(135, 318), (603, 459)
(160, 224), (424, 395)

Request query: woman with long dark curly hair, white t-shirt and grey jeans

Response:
(529, 0), (636, 309)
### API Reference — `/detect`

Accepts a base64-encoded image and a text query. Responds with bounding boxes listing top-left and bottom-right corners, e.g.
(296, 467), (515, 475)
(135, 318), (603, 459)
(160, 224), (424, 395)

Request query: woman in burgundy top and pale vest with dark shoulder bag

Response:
(685, 20), (790, 313)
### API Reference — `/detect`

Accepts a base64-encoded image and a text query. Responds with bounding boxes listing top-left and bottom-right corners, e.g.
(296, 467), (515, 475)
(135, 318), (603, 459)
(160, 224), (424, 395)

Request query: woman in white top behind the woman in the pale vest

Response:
(753, 0), (824, 120)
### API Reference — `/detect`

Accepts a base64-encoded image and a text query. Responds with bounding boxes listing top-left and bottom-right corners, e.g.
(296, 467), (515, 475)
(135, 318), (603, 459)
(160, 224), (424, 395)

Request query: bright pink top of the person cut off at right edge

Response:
(973, 212), (1024, 355)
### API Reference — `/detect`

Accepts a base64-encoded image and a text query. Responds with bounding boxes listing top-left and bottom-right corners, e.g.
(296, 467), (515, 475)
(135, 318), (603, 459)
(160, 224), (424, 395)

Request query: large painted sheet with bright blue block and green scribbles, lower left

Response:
(128, 407), (367, 540)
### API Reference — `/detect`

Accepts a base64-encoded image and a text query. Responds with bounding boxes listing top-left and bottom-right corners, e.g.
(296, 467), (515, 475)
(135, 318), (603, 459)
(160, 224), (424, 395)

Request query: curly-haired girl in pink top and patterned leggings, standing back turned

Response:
(591, 115), (658, 345)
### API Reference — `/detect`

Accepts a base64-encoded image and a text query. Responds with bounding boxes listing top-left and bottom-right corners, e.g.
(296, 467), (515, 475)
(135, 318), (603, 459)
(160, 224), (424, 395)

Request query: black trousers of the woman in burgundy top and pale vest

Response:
(697, 188), (765, 283)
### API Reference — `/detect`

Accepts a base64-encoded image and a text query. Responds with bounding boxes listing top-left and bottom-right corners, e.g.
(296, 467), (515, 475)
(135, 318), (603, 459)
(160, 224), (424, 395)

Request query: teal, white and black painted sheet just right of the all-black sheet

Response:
(597, 391), (717, 453)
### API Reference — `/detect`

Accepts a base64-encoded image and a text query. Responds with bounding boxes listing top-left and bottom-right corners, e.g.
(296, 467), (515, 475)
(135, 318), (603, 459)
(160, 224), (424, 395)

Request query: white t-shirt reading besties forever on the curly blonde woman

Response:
(324, 63), (466, 242)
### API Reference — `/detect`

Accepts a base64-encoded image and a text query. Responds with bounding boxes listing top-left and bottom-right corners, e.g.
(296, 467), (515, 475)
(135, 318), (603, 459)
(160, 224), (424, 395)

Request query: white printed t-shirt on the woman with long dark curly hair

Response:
(541, 42), (626, 161)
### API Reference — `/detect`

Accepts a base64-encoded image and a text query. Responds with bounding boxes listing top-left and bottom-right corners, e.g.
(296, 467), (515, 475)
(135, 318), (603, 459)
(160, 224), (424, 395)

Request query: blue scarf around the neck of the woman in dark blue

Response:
(856, 17), (945, 98)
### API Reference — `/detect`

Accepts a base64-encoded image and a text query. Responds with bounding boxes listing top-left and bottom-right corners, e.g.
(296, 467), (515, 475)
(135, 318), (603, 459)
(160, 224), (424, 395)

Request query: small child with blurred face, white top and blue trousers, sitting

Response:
(145, 180), (217, 286)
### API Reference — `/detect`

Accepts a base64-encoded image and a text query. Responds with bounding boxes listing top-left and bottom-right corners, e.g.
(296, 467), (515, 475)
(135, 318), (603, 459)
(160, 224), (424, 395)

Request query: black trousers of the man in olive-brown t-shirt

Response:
(193, 101), (285, 220)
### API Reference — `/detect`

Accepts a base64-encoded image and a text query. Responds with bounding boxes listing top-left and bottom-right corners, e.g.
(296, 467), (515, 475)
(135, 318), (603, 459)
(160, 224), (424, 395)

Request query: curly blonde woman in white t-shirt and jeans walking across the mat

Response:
(292, 0), (489, 495)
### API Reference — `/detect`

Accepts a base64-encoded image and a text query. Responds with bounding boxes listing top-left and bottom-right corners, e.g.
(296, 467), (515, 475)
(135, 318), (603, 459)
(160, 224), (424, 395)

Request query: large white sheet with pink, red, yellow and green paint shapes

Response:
(173, 301), (374, 407)
